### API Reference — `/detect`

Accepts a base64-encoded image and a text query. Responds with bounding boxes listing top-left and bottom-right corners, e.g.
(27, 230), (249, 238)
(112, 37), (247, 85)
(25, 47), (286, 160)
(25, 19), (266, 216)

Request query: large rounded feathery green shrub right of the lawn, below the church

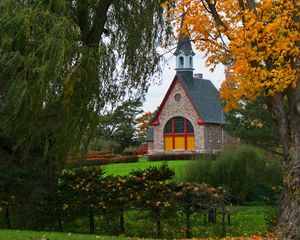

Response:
(185, 145), (282, 202)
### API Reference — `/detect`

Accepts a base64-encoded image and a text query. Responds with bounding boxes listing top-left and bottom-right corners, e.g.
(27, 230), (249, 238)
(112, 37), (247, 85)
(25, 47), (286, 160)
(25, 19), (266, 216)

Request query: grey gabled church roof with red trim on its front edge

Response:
(153, 71), (226, 124)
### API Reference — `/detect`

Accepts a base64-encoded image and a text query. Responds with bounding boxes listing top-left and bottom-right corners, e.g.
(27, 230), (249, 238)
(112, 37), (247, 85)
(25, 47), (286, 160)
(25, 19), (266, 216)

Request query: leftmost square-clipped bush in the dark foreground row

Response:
(56, 167), (105, 233)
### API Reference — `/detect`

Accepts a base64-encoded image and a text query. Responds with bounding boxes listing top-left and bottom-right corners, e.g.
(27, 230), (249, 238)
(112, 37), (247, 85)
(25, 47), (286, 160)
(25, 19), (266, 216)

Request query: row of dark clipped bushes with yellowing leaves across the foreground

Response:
(48, 162), (230, 238)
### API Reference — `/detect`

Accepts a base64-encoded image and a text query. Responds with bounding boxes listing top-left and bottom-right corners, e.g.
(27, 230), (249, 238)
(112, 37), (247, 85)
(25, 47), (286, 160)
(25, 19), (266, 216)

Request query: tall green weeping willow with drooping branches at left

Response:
(0, 0), (171, 228)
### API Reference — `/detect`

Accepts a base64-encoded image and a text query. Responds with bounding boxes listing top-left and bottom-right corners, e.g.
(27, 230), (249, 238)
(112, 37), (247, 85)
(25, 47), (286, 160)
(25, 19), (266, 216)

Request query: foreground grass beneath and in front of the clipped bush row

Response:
(0, 204), (269, 240)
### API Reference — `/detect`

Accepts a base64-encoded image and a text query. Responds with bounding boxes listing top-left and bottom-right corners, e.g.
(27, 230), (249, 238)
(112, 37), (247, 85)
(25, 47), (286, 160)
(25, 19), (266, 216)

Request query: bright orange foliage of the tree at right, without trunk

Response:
(165, 0), (300, 110)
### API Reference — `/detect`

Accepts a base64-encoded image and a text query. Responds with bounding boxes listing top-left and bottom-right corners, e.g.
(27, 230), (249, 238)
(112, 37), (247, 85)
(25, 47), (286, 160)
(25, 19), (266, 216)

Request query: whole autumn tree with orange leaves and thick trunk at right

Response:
(168, 0), (300, 239)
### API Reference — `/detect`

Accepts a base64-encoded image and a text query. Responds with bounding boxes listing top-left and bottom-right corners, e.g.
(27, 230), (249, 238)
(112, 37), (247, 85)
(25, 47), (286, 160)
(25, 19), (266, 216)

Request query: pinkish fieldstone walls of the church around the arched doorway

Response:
(148, 80), (238, 155)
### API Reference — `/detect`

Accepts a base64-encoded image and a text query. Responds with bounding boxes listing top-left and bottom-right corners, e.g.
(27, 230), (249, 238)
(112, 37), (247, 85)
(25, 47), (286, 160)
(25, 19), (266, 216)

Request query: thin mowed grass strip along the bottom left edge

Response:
(0, 230), (129, 240)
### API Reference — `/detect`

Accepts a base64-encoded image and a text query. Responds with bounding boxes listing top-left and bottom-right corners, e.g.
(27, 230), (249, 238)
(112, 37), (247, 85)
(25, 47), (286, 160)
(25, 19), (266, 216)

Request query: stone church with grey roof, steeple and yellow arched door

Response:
(146, 33), (236, 155)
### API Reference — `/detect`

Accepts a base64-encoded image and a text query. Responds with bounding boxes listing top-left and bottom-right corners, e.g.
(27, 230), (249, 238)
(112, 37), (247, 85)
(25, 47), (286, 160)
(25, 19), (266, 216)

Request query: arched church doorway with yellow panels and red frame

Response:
(164, 117), (195, 150)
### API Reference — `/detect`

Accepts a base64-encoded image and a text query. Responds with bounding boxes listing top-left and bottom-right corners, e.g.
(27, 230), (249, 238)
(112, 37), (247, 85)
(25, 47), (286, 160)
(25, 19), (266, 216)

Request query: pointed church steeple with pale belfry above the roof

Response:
(174, 16), (195, 72)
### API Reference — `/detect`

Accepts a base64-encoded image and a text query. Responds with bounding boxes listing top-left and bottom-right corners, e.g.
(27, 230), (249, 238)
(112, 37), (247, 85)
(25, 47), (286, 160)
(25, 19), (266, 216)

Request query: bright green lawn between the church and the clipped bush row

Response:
(104, 158), (191, 179)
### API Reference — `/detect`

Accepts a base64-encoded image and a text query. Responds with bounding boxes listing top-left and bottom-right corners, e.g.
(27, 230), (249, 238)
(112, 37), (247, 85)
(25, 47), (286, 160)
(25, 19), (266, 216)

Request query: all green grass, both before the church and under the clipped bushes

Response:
(0, 158), (270, 240)
